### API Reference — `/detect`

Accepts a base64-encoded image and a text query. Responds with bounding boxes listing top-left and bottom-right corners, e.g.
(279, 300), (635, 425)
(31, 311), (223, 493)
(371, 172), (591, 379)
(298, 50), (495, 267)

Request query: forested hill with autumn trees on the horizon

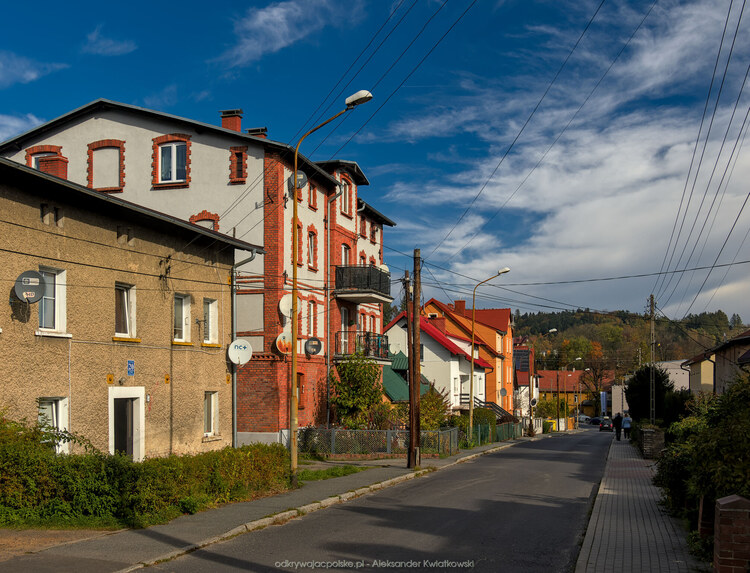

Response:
(513, 309), (744, 369)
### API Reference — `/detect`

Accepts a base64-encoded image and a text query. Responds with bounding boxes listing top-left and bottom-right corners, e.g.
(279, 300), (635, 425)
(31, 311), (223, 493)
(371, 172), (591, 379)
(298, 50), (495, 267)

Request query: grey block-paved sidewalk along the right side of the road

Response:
(575, 440), (710, 573)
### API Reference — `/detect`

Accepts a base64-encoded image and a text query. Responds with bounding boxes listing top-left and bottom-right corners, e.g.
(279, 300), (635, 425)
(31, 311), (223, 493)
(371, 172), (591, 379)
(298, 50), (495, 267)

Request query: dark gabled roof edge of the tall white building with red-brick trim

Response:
(0, 98), (338, 185)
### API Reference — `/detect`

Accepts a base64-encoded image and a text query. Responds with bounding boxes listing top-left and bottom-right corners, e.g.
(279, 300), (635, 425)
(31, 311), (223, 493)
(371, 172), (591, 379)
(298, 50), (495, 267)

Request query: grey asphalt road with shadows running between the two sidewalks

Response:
(152, 430), (612, 573)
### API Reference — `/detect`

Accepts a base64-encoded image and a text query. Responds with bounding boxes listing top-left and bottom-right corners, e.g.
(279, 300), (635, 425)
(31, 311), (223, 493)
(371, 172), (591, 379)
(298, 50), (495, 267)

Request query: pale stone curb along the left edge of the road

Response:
(116, 434), (532, 573)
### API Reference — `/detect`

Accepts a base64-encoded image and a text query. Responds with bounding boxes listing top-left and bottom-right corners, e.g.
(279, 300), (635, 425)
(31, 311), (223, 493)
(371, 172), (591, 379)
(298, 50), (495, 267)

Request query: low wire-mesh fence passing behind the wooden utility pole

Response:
(297, 428), (458, 456)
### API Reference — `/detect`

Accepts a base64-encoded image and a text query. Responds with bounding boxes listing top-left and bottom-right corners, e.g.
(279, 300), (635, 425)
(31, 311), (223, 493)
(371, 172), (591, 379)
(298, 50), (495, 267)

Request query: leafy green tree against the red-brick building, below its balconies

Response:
(330, 352), (383, 428)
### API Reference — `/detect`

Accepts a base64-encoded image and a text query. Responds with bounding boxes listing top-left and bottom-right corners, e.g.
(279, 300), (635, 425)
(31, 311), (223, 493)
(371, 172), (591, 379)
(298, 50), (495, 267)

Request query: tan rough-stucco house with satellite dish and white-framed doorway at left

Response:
(0, 157), (260, 460)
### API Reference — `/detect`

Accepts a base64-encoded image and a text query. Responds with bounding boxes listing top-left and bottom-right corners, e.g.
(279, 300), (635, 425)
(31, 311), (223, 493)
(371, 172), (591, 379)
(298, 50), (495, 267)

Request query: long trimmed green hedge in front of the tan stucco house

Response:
(0, 416), (289, 527)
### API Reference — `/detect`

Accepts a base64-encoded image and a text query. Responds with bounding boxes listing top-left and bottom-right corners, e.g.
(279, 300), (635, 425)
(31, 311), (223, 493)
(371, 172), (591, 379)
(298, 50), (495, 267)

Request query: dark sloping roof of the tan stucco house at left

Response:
(0, 157), (265, 254)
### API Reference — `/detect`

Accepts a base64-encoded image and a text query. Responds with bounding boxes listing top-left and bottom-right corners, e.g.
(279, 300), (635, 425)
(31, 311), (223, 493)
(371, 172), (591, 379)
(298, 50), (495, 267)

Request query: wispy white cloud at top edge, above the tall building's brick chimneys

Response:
(220, 0), (363, 67)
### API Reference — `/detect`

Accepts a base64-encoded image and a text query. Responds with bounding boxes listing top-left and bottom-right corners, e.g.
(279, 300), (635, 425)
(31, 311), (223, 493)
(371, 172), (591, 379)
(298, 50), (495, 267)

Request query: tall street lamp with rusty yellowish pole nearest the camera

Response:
(289, 90), (372, 486)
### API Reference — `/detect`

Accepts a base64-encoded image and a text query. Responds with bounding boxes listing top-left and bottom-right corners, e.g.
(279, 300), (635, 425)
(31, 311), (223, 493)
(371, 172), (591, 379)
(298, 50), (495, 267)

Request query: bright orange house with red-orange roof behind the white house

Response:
(422, 298), (513, 412)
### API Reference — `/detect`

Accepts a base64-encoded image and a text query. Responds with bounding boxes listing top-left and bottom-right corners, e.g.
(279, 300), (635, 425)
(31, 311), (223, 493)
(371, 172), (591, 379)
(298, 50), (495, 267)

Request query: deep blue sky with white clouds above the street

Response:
(0, 0), (750, 321)
